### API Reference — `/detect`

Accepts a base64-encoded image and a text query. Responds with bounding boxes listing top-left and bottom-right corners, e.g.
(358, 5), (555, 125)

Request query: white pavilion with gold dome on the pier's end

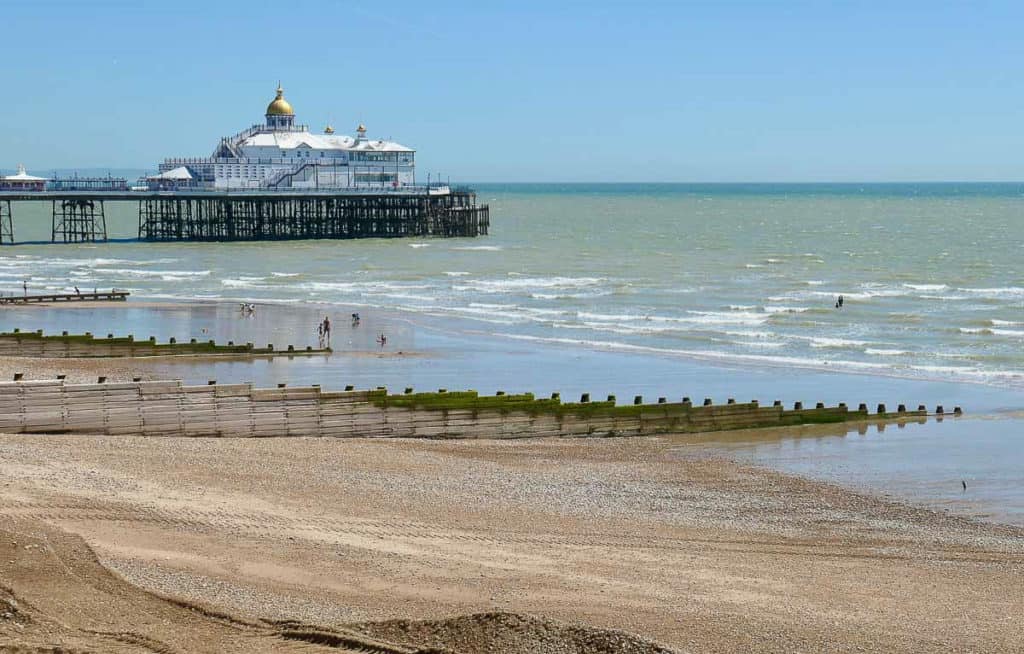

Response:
(154, 85), (416, 190)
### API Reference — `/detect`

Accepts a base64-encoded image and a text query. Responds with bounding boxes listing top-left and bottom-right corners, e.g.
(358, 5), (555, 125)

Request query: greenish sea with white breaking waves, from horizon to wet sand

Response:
(0, 184), (1024, 388)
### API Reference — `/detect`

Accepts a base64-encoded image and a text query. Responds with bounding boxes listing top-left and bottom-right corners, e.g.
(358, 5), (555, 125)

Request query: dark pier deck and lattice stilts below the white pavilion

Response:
(0, 186), (490, 244)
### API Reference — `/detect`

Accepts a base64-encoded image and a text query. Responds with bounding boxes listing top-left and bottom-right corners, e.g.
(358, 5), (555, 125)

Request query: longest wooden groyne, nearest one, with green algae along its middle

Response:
(0, 381), (959, 439)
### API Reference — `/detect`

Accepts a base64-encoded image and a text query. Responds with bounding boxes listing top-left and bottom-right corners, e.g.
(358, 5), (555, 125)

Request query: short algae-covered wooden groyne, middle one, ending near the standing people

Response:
(0, 330), (331, 358)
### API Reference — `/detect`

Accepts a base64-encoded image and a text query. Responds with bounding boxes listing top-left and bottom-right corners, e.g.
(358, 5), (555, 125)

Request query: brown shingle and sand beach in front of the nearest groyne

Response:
(0, 429), (1024, 653)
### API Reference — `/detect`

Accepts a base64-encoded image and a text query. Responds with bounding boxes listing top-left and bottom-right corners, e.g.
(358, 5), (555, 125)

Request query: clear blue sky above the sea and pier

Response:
(0, 0), (1024, 181)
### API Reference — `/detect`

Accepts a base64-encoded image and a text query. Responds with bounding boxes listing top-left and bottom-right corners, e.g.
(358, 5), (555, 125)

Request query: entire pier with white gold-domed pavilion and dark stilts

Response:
(0, 83), (490, 244)
